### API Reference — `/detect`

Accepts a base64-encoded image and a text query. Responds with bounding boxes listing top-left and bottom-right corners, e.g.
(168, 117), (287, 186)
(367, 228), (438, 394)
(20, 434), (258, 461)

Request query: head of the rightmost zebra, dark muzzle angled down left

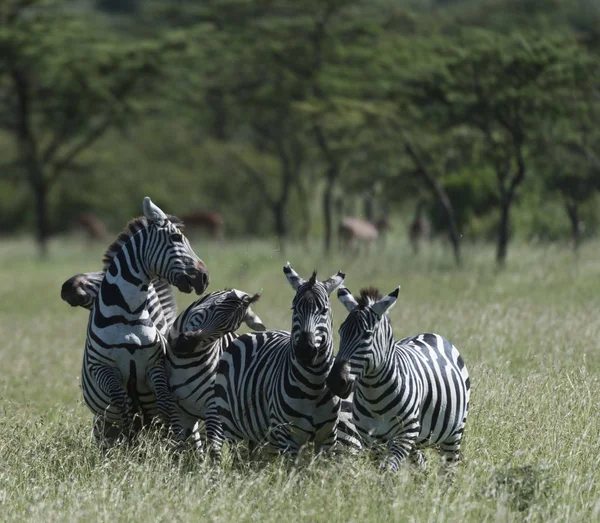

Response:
(327, 287), (400, 398)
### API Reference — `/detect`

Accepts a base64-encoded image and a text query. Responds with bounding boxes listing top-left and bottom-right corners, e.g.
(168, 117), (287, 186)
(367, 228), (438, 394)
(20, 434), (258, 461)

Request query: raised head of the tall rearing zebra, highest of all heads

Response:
(141, 196), (209, 294)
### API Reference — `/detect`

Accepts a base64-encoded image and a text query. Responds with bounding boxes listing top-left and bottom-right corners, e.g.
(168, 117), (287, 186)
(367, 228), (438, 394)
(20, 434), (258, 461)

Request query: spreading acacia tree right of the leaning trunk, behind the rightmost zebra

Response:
(409, 30), (577, 265)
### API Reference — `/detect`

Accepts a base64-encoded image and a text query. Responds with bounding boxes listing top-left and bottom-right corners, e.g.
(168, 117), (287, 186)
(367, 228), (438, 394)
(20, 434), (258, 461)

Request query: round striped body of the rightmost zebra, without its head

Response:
(353, 333), (469, 448)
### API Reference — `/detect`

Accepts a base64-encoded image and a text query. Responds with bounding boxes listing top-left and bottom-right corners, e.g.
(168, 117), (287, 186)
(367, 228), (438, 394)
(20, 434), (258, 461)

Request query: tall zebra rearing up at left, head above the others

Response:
(81, 197), (209, 447)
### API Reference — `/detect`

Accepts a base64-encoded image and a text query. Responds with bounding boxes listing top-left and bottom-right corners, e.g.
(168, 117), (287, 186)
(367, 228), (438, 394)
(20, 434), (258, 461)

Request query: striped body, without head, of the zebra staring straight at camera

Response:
(215, 331), (340, 453)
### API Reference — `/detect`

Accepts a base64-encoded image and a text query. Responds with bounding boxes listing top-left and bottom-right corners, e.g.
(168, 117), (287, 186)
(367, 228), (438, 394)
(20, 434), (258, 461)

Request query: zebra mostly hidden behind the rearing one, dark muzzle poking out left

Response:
(60, 271), (177, 336)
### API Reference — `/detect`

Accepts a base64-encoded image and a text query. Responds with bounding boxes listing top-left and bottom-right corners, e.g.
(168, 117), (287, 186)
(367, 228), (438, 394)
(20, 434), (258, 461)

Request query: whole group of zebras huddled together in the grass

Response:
(61, 197), (470, 471)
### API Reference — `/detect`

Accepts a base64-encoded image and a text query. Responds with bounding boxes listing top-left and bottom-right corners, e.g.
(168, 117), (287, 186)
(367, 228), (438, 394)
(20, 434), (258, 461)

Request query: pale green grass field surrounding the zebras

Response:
(0, 240), (600, 522)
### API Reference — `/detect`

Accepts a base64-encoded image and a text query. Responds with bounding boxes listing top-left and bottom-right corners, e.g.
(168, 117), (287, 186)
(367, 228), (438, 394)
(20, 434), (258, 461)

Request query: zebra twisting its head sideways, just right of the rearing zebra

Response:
(166, 289), (266, 449)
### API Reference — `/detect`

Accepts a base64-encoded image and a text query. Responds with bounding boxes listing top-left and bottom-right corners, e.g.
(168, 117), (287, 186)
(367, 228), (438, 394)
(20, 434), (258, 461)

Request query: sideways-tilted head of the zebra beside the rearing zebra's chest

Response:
(169, 289), (266, 353)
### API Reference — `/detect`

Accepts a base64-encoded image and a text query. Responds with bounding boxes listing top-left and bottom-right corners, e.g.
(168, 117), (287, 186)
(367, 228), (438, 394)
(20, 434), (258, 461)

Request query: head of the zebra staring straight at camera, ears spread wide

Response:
(283, 262), (346, 365)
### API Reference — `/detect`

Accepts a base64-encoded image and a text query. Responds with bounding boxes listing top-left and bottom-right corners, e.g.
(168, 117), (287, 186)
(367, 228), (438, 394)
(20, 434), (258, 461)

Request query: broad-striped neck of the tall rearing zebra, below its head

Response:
(98, 251), (150, 317)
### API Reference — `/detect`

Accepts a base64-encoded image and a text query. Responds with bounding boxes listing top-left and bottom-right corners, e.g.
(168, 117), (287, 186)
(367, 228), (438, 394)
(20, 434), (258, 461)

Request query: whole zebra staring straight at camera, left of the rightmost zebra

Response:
(206, 262), (345, 462)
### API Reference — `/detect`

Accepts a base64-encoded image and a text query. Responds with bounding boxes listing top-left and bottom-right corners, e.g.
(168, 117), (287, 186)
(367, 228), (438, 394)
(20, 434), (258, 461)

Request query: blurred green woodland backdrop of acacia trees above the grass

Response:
(0, 0), (600, 264)
